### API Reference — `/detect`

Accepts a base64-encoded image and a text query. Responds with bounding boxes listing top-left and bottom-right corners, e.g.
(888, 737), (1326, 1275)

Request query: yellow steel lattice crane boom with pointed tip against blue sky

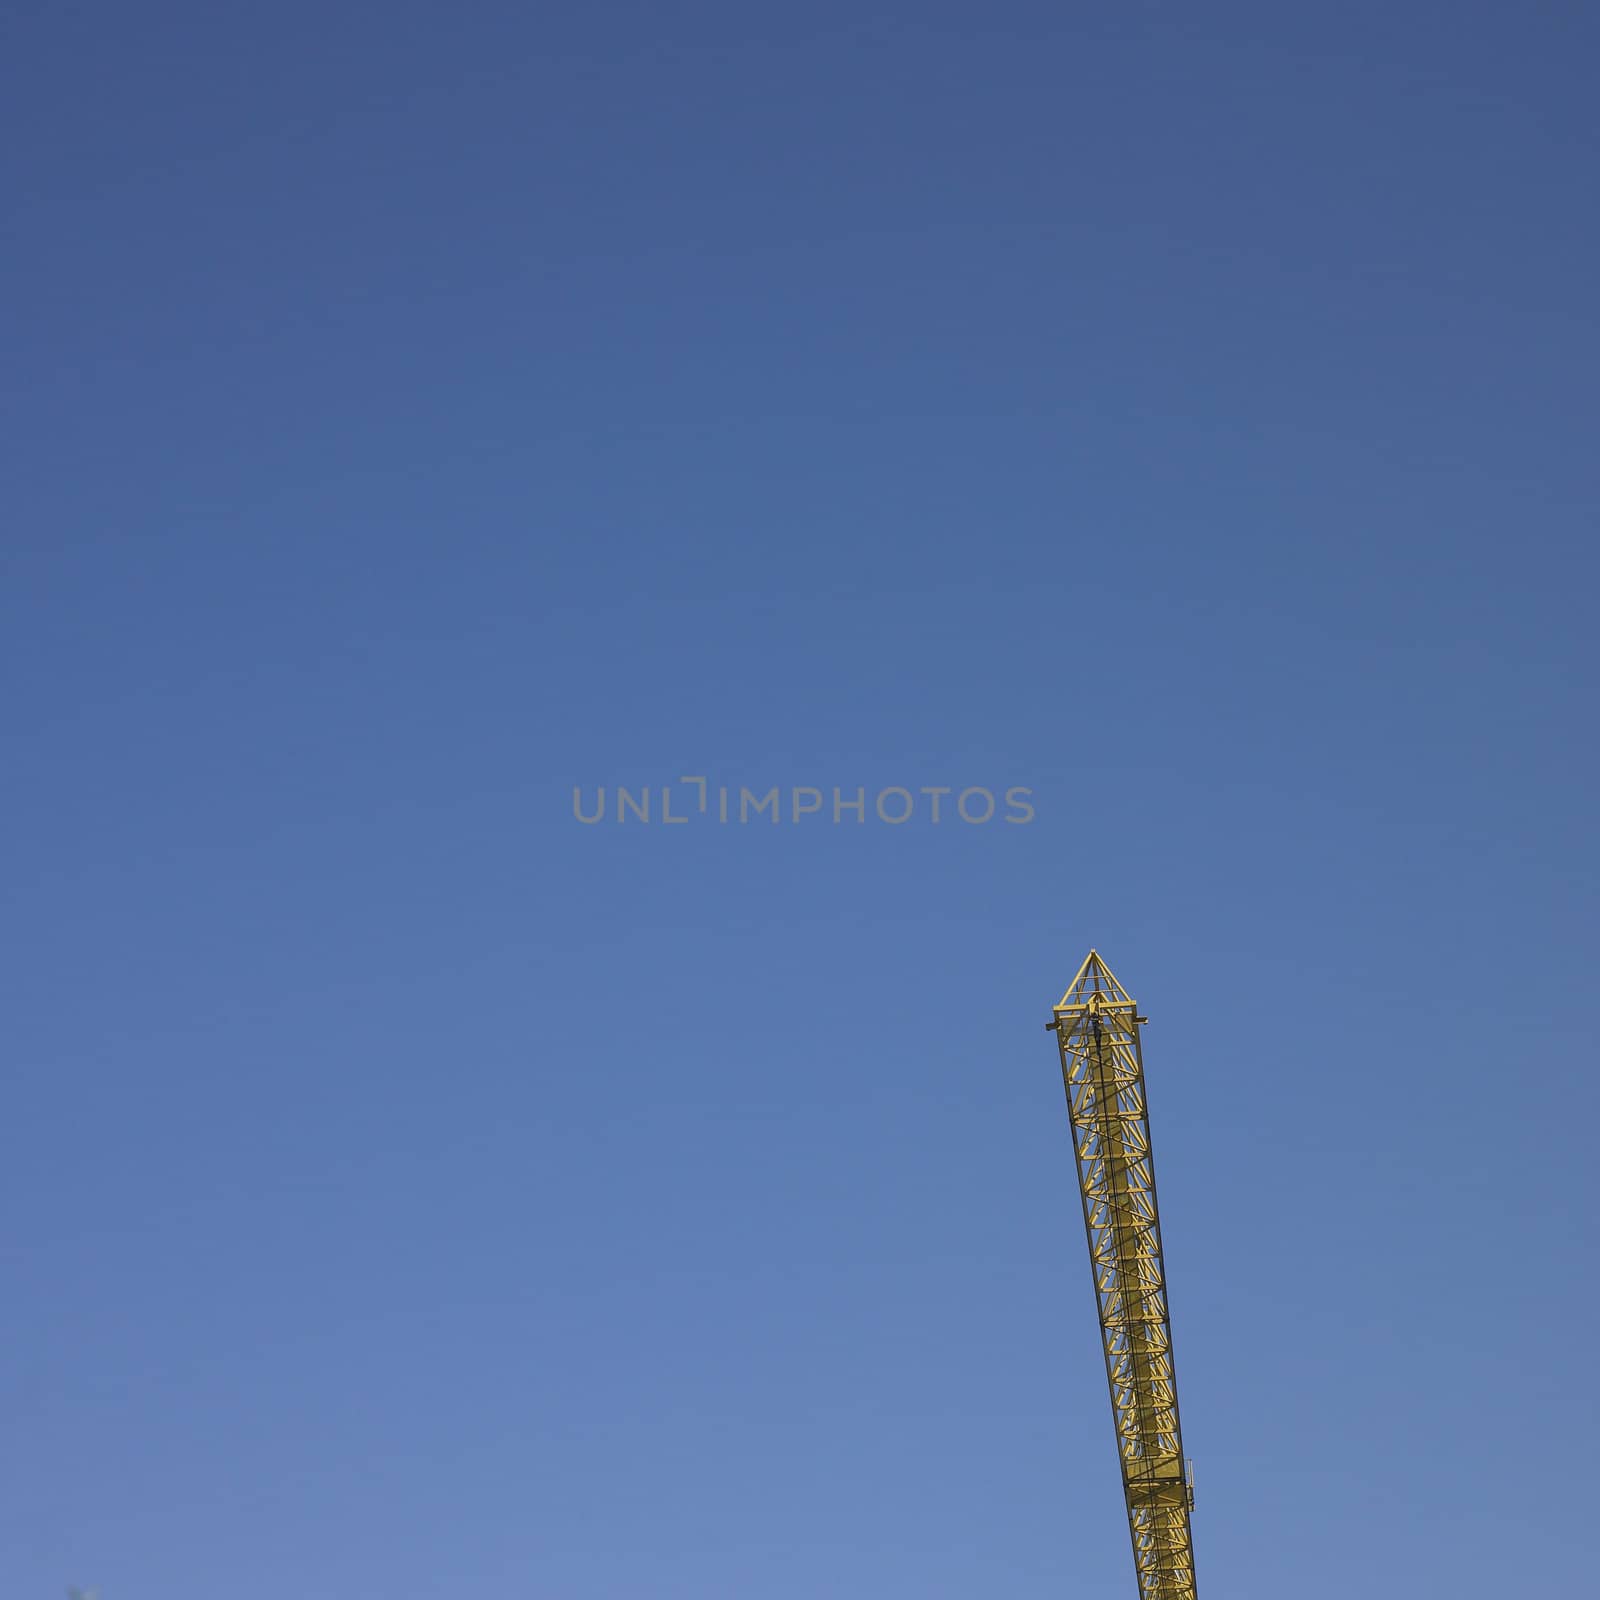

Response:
(1045, 950), (1195, 1600)
